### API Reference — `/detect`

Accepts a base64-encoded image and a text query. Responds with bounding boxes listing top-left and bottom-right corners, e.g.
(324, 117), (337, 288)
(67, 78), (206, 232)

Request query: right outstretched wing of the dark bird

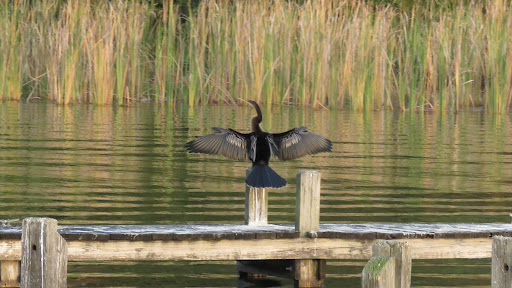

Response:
(272, 127), (332, 161)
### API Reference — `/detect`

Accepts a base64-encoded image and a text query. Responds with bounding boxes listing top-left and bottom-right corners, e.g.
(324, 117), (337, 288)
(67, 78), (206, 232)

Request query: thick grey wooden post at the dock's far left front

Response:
(21, 218), (68, 288)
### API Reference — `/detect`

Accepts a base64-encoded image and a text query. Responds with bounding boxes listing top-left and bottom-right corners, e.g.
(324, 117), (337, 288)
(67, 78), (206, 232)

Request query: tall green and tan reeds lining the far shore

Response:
(0, 0), (512, 113)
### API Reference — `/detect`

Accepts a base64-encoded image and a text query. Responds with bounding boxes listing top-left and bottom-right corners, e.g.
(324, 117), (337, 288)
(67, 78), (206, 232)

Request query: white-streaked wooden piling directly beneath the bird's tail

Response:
(245, 167), (268, 226)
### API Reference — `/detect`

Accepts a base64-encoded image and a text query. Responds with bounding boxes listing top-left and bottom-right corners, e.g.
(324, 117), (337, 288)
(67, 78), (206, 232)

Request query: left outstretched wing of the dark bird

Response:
(185, 127), (250, 161)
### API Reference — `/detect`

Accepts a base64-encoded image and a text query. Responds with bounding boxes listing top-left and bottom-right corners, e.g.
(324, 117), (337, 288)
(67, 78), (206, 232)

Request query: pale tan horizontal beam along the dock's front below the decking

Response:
(0, 238), (498, 261)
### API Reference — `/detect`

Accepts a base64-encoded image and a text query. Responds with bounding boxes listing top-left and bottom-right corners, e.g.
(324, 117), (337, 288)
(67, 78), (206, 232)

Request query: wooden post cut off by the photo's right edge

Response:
(491, 236), (512, 288)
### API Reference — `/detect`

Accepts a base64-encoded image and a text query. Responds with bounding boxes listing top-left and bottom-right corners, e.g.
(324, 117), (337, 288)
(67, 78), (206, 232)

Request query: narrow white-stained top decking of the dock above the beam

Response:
(0, 223), (512, 241)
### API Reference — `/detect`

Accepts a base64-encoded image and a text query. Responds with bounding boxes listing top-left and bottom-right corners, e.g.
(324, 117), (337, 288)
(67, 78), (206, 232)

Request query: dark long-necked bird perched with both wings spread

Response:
(186, 99), (332, 188)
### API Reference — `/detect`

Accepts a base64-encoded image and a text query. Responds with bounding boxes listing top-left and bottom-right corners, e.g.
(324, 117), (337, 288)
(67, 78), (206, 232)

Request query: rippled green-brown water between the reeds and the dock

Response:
(0, 103), (512, 287)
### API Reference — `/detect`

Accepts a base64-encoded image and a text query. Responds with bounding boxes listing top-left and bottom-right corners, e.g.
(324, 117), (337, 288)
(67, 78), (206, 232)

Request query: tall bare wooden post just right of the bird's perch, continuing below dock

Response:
(294, 171), (326, 287)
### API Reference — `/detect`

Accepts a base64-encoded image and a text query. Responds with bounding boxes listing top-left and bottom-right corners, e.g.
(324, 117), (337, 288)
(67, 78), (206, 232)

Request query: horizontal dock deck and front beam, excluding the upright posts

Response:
(0, 223), (512, 261)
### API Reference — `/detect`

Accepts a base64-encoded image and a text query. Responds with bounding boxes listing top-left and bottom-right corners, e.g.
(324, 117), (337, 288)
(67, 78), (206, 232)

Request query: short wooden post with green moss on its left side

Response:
(362, 240), (412, 288)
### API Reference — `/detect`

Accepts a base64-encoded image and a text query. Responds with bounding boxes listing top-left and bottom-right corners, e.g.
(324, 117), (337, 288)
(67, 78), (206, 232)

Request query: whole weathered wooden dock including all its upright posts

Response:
(0, 171), (512, 288)
